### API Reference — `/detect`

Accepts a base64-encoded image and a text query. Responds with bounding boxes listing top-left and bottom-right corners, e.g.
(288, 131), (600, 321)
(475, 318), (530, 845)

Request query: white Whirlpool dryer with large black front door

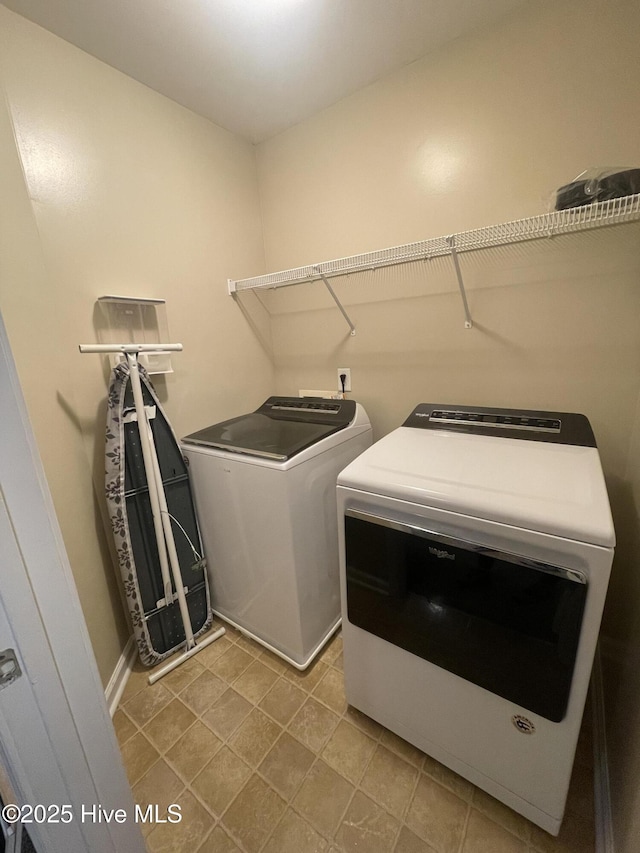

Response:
(337, 403), (615, 835)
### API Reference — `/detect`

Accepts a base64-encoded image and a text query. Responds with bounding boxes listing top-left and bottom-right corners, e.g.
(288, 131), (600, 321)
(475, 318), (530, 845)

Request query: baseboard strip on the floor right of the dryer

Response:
(591, 645), (615, 853)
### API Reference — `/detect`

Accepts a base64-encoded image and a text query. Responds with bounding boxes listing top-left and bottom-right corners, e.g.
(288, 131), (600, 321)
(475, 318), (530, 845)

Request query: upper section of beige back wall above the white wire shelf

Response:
(258, 0), (640, 270)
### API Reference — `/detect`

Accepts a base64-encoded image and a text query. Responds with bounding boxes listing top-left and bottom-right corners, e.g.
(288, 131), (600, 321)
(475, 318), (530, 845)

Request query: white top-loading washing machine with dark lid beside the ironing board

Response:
(182, 397), (371, 669)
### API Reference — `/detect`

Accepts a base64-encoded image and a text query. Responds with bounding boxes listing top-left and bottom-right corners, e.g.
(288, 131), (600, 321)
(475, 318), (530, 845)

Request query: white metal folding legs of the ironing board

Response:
(80, 344), (225, 684)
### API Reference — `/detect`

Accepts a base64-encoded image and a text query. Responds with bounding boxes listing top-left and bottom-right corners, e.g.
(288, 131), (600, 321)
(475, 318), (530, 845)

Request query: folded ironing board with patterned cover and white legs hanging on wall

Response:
(80, 344), (224, 683)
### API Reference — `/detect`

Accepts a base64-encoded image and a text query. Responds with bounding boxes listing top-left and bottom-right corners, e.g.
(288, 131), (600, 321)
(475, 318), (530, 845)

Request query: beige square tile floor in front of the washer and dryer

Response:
(113, 629), (594, 853)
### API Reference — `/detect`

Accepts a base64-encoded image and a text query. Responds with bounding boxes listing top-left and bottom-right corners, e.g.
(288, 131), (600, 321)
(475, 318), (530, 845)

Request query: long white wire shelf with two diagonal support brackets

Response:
(228, 193), (640, 335)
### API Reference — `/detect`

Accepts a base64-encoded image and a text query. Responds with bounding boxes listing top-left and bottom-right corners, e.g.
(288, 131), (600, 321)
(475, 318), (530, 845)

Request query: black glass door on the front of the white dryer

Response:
(345, 510), (587, 722)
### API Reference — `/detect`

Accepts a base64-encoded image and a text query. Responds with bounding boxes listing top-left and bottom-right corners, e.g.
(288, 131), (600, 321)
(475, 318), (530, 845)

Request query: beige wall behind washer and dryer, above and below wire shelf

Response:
(254, 0), (640, 851)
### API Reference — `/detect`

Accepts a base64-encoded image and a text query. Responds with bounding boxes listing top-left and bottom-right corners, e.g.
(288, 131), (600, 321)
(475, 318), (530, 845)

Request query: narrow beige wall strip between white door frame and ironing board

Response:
(0, 70), (129, 682)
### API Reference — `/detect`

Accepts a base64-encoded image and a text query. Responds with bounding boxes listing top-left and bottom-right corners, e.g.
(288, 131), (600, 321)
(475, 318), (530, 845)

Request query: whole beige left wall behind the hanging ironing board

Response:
(0, 6), (273, 683)
